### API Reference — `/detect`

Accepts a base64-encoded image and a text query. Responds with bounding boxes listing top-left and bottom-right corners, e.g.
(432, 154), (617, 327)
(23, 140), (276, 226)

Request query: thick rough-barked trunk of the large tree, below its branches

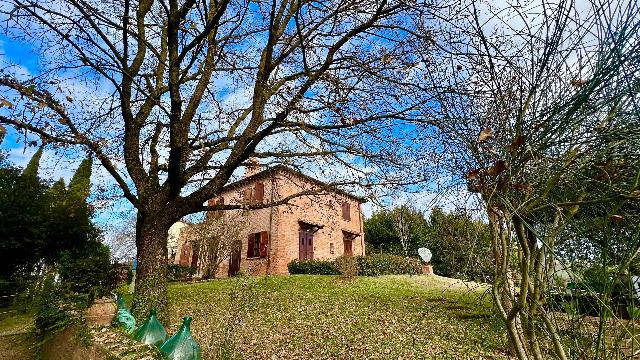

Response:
(132, 213), (171, 322)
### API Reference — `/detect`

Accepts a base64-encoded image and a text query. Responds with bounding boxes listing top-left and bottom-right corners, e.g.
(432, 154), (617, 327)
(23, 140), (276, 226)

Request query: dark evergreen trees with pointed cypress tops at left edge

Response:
(0, 153), (100, 280)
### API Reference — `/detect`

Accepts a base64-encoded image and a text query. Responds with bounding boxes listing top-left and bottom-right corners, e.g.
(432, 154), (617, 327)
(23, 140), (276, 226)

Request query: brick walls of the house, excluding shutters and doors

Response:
(176, 167), (364, 277)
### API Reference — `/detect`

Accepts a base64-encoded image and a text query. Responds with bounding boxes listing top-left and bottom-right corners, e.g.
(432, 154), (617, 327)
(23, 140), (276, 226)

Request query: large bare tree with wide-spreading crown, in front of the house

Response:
(0, 0), (424, 316)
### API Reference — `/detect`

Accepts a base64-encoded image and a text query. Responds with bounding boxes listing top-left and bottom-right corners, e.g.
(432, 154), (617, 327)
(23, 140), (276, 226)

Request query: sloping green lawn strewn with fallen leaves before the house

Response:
(167, 275), (506, 359)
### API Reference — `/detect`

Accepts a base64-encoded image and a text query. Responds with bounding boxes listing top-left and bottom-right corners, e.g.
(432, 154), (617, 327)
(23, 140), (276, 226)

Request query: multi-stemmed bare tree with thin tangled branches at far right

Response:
(422, 0), (640, 359)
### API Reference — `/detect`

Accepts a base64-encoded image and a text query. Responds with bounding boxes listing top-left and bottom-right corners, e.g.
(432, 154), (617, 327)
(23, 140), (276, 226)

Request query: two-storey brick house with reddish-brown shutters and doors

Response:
(174, 166), (364, 277)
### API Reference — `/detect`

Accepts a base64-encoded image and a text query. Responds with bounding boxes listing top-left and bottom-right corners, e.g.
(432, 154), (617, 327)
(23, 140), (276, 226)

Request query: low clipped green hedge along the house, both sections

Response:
(287, 254), (422, 276)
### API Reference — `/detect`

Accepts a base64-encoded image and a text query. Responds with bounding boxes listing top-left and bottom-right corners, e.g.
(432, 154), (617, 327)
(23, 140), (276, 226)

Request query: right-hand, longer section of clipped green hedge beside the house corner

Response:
(357, 254), (422, 276)
